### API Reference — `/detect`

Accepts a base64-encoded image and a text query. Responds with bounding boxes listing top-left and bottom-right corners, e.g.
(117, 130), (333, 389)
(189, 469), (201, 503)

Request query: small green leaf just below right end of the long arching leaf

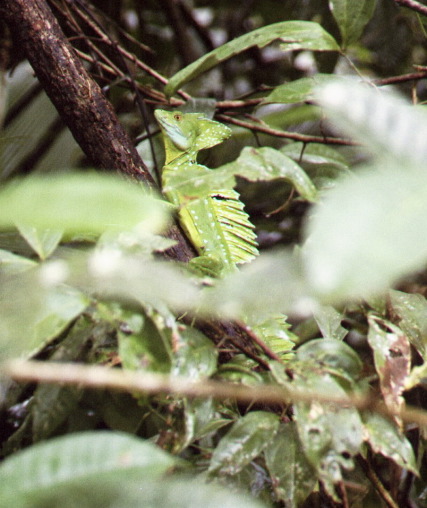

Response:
(262, 73), (337, 104)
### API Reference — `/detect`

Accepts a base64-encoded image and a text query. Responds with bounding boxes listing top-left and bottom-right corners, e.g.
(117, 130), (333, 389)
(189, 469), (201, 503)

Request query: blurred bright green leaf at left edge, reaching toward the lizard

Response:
(0, 173), (171, 233)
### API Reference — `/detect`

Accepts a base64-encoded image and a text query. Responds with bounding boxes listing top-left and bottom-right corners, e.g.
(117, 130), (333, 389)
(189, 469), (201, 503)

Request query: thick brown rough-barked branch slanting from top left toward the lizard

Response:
(0, 0), (152, 183)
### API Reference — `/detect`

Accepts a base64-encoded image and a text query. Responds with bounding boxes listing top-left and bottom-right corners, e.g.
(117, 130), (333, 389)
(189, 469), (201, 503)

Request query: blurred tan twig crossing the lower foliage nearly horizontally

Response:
(5, 360), (427, 427)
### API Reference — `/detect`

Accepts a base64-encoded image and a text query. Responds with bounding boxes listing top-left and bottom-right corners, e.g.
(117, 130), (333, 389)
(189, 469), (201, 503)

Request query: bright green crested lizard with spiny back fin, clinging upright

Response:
(154, 110), (258, 276)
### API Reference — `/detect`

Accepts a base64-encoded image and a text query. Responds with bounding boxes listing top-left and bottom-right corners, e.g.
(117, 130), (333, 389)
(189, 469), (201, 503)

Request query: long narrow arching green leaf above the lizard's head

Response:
(165, 21), (339, 95)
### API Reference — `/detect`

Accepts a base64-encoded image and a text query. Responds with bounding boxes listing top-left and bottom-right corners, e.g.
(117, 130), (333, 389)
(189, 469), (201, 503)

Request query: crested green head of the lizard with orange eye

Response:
(154, 109), (231, 157)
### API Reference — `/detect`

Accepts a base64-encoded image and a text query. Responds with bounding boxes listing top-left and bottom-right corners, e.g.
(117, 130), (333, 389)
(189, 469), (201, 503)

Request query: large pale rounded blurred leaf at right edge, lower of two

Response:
(303, 165), (427, 301)
